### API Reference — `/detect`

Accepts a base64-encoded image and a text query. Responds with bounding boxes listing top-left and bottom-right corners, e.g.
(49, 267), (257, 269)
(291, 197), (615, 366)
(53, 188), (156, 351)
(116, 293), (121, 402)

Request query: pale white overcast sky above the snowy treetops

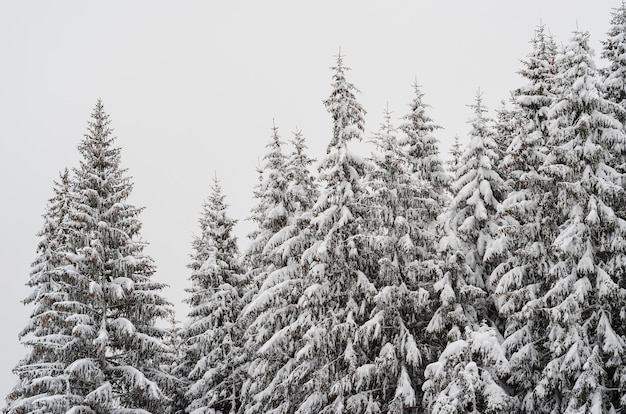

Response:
(0, 0), (619, 406)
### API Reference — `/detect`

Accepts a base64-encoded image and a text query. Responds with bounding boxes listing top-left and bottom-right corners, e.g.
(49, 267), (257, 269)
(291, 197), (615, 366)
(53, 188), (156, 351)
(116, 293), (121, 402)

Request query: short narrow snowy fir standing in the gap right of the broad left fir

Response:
(179, 178), (241, 413)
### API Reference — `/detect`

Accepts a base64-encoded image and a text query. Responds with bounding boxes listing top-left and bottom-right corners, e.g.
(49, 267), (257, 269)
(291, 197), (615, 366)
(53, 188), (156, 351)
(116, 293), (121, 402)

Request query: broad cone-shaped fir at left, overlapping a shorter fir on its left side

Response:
(8, 101), (172, 413)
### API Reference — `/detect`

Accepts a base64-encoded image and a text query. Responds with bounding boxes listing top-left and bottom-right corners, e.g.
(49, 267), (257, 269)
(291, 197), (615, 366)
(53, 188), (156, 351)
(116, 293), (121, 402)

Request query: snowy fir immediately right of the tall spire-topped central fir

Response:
(345, 106), (428, 413)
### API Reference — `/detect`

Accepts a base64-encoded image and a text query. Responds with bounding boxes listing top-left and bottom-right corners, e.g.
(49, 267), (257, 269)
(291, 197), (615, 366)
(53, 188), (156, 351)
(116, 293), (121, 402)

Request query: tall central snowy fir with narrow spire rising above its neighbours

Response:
(287, 54), (376, 413)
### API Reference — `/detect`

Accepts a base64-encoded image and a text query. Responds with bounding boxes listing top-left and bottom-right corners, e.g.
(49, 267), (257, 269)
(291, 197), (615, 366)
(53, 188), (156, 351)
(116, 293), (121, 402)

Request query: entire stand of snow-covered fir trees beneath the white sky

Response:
(5, 5), (626, 414)
